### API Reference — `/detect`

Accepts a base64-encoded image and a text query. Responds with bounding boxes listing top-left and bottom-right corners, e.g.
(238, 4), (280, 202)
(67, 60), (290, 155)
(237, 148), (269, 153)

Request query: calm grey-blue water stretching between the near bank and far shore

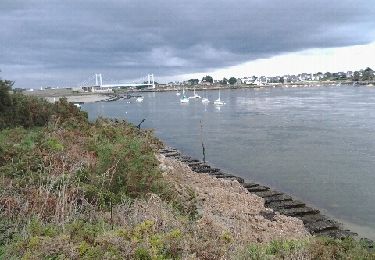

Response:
(83, 86), (375, 239)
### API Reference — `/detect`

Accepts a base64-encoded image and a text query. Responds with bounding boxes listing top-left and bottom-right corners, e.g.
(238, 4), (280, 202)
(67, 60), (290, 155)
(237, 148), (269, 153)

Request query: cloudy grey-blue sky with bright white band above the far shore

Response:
(0, 0), (375, 88)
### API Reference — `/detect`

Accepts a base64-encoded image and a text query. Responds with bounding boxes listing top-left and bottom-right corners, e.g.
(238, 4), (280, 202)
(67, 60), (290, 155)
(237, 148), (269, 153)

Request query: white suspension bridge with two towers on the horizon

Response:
(78, 73), (155, 92)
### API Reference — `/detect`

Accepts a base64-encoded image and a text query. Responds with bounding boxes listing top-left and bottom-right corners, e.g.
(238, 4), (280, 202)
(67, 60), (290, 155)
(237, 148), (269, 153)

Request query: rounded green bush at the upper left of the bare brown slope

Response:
(79, 120), (167, 206)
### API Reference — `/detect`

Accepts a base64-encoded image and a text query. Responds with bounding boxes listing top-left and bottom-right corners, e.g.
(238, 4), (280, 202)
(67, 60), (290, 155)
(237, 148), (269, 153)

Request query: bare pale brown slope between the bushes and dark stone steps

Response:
(158, 150), (309, 245)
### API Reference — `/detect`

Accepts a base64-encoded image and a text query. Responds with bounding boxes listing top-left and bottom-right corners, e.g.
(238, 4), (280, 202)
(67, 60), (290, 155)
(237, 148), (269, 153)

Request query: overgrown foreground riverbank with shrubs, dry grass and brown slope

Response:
(0, 118), (371, 259)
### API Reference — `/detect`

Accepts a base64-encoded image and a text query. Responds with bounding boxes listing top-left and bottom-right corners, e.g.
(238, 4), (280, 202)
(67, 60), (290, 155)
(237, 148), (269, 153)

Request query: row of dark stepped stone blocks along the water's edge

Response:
(160, 148), (364, 242)
